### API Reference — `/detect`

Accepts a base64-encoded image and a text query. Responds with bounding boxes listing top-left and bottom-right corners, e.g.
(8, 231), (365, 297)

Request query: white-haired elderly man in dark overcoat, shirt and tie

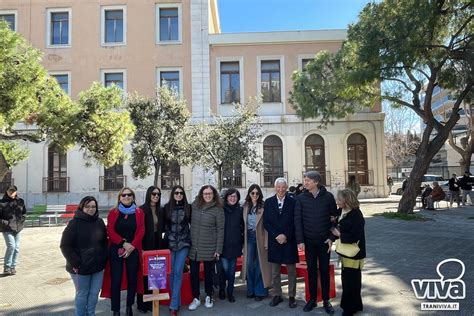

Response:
(263, 178), (298, 308)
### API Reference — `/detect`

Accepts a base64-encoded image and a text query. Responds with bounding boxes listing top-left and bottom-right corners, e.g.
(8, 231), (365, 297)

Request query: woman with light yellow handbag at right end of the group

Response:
(331, 189), (365, 315)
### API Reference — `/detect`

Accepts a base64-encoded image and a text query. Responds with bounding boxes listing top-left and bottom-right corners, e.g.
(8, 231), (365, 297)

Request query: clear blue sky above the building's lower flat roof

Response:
(217, 0), (370, 33)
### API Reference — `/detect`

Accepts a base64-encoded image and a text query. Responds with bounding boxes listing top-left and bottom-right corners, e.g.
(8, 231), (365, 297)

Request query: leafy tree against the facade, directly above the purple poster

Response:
(128, 86), (190, 186)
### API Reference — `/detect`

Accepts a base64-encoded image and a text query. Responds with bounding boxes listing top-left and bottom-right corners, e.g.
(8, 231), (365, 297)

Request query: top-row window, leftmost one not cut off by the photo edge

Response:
(46, 8), (71, 47)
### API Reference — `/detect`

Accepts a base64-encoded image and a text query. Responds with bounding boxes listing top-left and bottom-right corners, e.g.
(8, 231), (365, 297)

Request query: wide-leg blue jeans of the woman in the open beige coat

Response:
(245, 231), (268, 296)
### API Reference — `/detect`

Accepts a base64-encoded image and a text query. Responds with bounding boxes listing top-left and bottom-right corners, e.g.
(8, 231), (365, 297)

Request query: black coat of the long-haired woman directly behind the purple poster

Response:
(140, 204), (168, 250)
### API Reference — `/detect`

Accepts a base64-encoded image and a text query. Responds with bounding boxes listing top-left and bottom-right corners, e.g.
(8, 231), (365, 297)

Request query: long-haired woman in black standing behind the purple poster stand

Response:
(137, 186), (166, 313)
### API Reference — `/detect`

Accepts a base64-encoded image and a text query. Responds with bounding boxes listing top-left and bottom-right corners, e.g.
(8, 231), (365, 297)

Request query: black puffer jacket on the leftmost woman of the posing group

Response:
(60, 210), (107, 275)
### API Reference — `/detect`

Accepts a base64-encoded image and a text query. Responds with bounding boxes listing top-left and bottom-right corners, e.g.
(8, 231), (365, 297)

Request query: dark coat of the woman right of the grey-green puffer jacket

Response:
(222, 203), (244, 259)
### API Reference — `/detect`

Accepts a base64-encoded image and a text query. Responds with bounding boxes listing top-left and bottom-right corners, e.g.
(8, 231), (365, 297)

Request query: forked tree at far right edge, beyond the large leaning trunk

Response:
(448, 104), (474, 172)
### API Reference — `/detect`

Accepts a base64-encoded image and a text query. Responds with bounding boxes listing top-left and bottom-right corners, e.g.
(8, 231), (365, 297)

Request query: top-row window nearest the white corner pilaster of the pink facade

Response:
(156, 3), (182, 44)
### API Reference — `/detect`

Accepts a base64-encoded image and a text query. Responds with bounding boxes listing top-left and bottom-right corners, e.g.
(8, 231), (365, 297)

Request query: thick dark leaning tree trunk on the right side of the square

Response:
(398, 126), (449, 214)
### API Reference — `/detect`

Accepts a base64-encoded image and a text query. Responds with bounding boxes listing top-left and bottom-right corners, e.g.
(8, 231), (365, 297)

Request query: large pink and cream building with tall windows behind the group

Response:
(0, 0), (388, 206)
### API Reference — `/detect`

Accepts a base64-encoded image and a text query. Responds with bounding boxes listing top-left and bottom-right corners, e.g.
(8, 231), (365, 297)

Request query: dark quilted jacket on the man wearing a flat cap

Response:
(295, 186), (337, 244)
